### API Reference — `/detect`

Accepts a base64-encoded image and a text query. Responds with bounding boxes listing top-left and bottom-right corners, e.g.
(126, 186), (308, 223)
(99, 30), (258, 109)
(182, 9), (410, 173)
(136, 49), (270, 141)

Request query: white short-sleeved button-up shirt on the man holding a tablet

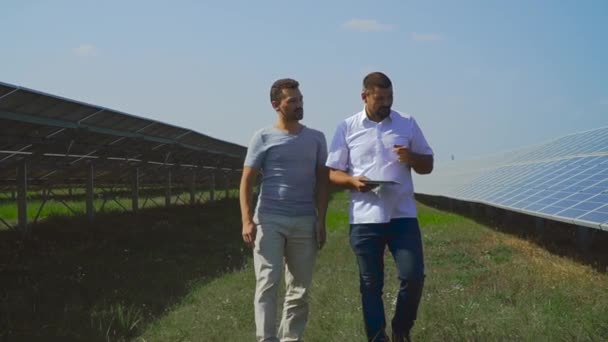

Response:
(326, 109), (433, 224)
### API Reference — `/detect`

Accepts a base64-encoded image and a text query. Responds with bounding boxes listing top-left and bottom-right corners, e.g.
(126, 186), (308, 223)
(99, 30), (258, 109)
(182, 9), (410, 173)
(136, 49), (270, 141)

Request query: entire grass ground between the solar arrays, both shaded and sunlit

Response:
(0, 193), (608, 342)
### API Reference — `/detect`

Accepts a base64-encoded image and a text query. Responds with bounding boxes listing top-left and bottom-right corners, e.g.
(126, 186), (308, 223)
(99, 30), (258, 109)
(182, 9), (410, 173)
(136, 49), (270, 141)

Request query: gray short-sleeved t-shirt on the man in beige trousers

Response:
(245, 126), (327, 216)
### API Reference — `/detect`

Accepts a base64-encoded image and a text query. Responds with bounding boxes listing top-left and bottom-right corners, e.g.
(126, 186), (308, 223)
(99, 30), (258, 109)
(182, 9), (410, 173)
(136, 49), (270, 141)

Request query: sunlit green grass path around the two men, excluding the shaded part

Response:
(137, 194), (608, 342)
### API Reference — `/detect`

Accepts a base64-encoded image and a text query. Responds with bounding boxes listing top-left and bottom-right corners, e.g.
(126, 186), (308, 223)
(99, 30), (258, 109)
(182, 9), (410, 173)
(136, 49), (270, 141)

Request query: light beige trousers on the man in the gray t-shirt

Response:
(253, 214), (317, 342)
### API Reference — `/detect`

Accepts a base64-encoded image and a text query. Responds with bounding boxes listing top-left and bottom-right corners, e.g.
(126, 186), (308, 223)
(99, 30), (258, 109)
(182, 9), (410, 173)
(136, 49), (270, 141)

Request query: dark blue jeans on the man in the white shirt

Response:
(350, 218), (424, 342)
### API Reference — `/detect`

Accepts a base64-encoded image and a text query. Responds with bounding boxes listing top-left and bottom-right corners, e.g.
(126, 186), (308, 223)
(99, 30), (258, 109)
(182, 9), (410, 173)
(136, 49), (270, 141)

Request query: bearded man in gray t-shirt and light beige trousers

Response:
(240, 79), (329, 341)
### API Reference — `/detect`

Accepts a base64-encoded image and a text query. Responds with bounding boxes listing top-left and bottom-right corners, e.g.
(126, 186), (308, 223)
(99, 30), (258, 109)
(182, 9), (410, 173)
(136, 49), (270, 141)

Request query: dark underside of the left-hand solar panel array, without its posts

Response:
(0, 82), (246, 186)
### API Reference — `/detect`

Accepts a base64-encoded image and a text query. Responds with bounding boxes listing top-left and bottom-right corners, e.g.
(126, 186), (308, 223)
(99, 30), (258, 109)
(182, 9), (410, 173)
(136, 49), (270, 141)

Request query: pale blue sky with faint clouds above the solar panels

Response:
(0, 0), (608, 160)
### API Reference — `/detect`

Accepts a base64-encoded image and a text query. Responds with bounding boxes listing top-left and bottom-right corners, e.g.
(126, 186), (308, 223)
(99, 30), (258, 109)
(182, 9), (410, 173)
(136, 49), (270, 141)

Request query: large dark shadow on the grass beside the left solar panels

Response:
(0, 199), (250, 341)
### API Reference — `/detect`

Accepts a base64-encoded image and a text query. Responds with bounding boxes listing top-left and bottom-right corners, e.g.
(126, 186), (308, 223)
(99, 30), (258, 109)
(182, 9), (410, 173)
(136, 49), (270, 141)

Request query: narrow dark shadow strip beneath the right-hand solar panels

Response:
(416, 194), (608, 273)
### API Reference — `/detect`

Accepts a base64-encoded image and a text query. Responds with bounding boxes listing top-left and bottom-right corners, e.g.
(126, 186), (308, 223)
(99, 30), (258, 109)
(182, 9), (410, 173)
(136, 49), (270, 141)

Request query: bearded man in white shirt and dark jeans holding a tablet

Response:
(326, 72), (433, 342)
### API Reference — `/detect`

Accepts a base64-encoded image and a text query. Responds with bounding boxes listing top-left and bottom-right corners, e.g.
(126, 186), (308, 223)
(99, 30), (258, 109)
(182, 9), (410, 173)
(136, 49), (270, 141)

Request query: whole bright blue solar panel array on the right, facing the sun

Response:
(415, 127), (608, 230)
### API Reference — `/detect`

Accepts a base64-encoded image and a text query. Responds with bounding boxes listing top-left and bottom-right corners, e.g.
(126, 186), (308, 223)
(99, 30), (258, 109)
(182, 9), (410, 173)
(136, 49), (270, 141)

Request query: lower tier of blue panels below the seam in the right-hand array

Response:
(451, 155), (608, 224)
